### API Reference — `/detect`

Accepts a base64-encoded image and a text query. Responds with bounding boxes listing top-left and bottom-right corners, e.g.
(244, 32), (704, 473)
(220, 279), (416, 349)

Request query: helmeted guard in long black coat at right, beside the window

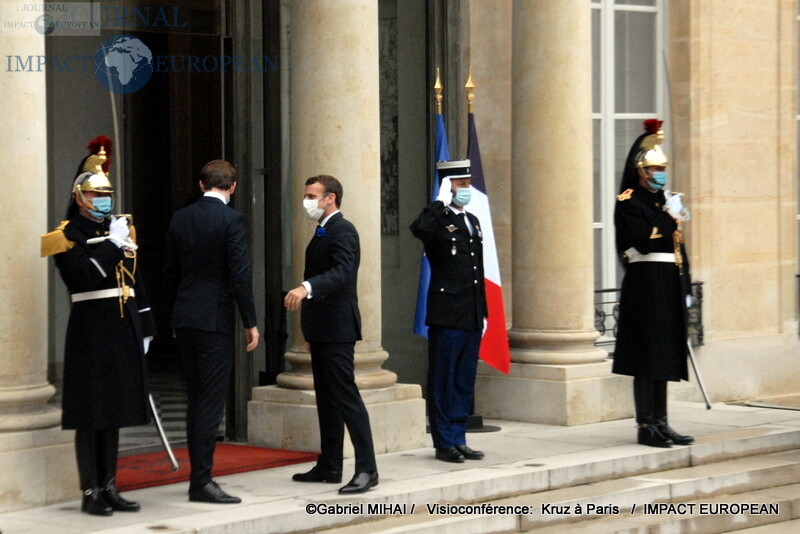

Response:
(613, 119), (694, 448)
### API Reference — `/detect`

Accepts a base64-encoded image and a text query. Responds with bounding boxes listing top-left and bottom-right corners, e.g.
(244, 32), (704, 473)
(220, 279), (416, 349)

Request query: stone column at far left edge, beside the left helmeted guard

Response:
(0, 29), (78, 512)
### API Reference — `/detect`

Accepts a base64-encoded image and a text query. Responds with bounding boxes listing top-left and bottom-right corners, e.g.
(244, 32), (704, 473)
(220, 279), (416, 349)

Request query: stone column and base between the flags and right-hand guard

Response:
(478, 0), (631, 425)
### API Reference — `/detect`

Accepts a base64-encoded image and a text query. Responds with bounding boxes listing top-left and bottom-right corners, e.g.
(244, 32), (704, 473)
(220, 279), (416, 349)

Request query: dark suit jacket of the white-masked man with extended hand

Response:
(300, 213), (361, 343)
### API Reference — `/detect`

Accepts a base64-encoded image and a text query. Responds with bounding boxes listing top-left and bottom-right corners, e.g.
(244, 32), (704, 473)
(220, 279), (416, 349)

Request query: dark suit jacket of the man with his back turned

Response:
(164, 196), (256, 334)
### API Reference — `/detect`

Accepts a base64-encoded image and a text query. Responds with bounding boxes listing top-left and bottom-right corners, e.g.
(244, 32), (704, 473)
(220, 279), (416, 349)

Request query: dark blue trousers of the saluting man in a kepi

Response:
(426, 326), (481, 449)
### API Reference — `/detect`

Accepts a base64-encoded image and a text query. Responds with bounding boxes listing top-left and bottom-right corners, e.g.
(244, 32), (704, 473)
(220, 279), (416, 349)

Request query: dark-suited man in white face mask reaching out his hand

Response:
(284, 175), (378, 494)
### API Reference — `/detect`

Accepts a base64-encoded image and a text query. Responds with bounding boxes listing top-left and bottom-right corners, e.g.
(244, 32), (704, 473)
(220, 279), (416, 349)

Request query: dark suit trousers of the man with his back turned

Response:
(175, 328), (234, 489)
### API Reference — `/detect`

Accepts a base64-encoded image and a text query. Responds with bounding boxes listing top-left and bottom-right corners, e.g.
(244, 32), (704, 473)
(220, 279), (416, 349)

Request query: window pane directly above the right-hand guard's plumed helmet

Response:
(614, 11), (658, 113)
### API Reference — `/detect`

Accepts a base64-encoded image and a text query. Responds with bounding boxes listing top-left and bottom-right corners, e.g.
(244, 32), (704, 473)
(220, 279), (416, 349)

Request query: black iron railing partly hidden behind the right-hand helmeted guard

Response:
(594, 282), (703, 354)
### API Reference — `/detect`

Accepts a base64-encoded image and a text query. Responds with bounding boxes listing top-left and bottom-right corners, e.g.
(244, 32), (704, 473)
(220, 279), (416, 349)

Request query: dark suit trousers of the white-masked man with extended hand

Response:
(309, 342), (378, 473)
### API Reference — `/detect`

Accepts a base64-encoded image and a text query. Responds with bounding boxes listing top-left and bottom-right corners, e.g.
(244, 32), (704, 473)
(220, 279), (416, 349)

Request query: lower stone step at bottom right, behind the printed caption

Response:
(314, 450), (800, 534)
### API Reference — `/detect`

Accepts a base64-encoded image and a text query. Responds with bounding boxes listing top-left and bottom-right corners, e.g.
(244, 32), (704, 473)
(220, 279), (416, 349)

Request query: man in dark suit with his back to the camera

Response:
(164, 160), (259, 503)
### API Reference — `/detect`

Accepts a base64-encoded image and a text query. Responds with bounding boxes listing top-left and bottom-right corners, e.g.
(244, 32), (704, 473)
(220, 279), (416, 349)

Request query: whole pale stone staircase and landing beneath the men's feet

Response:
(0, 402), (800, 534)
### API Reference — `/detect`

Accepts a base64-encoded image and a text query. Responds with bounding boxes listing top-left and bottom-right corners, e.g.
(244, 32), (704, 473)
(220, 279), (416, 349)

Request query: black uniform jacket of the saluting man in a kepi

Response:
(410, 200), (488, 330)
